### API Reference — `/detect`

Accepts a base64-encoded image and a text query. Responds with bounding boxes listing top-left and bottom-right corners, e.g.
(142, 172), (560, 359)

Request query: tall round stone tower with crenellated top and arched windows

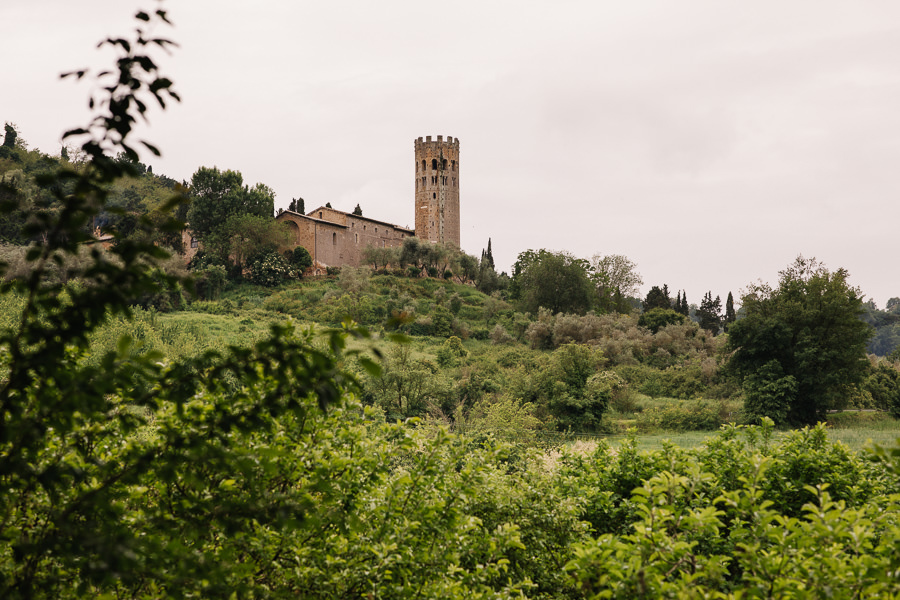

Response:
(415, 135), (459, 247)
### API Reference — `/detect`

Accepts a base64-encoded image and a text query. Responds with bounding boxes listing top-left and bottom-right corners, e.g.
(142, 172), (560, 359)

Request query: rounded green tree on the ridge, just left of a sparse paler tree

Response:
(510, 250), (595, 314)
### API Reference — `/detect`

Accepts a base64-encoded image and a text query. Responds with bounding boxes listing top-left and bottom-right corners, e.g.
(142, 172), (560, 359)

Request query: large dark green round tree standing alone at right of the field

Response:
(728, 256), (871, 425)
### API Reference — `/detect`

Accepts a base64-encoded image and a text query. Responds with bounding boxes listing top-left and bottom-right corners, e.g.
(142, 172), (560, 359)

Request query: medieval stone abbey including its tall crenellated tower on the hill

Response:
(275, 135), (459, 267)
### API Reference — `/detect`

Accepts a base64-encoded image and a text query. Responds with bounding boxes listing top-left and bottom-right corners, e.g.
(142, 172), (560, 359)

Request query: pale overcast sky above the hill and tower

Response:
(0, 0), (900, 308)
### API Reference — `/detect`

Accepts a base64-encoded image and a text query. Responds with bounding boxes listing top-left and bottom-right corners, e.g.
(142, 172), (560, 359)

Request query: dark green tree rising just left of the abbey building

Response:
(187, 167), (275, 243)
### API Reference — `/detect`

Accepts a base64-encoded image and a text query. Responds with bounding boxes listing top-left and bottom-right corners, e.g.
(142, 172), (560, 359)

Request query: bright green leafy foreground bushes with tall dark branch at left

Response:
(0, 5), (900, 598)
